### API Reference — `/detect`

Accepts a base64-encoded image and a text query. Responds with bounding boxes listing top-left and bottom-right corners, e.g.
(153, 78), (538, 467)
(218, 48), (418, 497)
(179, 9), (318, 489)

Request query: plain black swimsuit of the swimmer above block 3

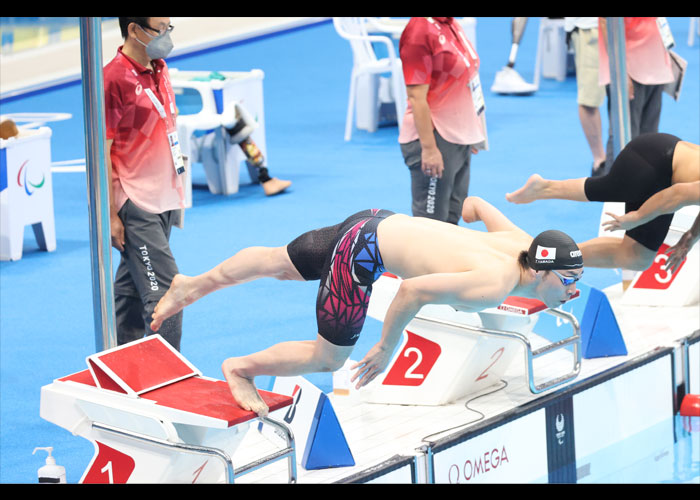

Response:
(584, 133), (681, 252)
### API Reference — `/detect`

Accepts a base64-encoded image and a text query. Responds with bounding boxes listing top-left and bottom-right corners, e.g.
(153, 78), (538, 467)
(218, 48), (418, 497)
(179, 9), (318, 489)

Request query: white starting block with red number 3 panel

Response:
(598, 203), (700, 307)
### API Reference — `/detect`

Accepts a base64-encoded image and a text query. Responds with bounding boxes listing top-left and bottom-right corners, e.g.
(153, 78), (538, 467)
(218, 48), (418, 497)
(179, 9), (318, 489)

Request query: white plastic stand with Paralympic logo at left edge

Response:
(0, 127), (56, 260)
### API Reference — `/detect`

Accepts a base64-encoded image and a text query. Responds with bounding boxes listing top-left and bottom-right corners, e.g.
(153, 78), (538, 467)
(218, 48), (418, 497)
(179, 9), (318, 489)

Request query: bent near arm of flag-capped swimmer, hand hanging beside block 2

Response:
(350, 269), (508, 389)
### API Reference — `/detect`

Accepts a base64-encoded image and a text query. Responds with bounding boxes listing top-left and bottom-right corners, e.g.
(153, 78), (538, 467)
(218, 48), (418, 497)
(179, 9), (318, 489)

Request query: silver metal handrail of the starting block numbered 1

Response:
(92, 417), (297, 484)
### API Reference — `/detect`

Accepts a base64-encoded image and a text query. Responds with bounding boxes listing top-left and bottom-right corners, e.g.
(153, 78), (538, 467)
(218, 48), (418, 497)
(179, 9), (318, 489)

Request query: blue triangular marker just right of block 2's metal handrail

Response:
(581, 287), (627, 359)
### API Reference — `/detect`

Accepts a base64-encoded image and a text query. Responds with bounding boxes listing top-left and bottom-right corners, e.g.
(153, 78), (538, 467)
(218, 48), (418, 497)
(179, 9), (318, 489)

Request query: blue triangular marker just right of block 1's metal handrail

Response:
(301, 394), (355, 470)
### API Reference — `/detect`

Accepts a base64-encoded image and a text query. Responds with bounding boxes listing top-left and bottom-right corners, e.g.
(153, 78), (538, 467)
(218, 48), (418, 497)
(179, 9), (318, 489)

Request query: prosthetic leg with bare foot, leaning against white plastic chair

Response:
(221, 101), (292, 196)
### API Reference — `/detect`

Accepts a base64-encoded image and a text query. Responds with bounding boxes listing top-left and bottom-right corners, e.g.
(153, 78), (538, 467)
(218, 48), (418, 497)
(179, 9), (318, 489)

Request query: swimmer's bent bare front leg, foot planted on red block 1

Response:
(221, 335), (353, 416)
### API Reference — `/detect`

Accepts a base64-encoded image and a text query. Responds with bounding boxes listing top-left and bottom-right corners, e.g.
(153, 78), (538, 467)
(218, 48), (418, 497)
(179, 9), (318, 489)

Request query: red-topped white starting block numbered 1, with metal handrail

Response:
(40, 335), (296, 483)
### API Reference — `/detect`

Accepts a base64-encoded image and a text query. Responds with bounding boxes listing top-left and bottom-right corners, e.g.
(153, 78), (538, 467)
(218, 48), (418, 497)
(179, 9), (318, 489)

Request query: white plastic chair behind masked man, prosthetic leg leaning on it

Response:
(170, 68), (267, 206)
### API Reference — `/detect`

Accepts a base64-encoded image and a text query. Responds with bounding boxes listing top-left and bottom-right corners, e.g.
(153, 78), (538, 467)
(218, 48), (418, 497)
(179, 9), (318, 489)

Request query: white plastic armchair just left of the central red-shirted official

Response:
(333, 17), (406, 141)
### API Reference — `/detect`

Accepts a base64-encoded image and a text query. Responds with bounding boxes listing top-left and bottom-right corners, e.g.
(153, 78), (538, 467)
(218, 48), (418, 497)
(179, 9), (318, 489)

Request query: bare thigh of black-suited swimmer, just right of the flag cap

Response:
(579, 235), (656, 271)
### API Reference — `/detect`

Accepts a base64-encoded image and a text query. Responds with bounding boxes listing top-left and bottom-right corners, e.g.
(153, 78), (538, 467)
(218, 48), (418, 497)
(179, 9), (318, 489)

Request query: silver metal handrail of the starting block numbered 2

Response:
(414, 309), (581, 394)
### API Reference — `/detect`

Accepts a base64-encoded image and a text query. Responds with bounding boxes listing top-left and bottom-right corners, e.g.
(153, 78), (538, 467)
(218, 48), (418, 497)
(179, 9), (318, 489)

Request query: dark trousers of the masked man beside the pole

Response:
(114, 200), (182, 350)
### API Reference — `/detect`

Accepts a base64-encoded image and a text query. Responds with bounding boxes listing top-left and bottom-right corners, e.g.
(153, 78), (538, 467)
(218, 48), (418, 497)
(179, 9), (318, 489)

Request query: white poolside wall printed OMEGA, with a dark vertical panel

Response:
(432, 348), (680, 483)
